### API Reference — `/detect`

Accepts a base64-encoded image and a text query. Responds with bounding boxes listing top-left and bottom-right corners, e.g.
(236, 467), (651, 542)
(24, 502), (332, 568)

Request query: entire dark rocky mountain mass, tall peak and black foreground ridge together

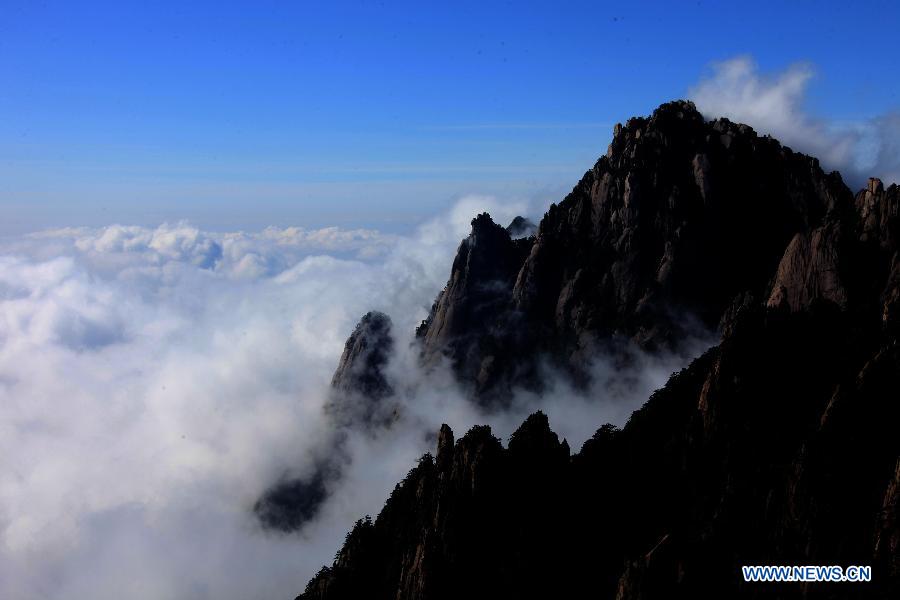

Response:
(292, 102), (900, 600)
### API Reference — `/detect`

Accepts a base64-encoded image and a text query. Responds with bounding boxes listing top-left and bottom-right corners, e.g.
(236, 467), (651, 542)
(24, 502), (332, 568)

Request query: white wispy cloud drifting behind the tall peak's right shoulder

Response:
(688, 56), (900, 187)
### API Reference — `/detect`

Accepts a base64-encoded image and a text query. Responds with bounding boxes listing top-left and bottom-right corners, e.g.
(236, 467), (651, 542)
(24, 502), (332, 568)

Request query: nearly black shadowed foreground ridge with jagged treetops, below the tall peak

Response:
(300, 305), (900, 600)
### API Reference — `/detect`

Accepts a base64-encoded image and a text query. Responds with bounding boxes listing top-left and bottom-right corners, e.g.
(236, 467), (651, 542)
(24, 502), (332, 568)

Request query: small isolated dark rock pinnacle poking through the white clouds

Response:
(253, 312), (396, 531)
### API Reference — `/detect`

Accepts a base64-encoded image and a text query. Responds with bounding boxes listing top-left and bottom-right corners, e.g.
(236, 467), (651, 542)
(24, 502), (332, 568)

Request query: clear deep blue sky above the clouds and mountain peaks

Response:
(0, 0), (900, 233)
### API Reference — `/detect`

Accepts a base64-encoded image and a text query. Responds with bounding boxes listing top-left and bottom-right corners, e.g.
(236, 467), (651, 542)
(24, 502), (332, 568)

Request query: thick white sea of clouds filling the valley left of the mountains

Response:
(0, 197), (708, 600)
